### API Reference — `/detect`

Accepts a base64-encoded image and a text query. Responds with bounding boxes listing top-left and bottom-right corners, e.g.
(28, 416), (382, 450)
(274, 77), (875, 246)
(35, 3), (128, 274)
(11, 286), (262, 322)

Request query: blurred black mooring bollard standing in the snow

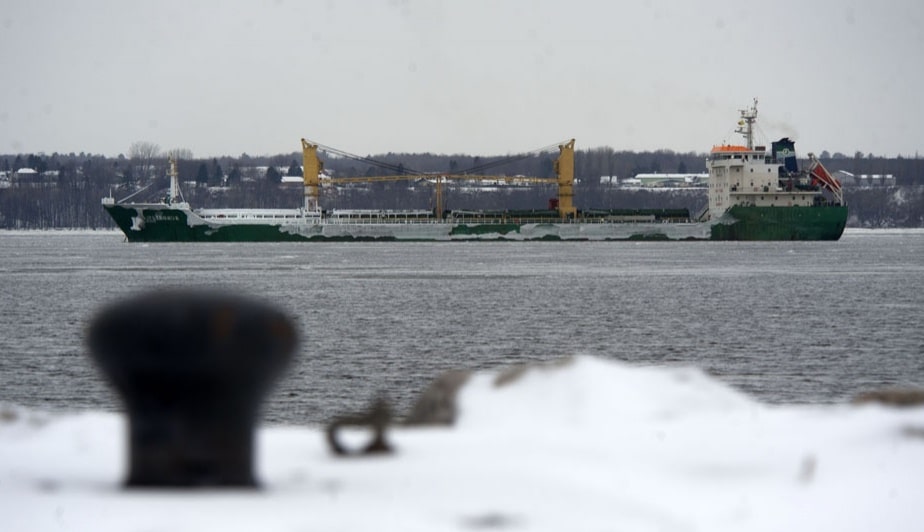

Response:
(87, 289), (297, 487)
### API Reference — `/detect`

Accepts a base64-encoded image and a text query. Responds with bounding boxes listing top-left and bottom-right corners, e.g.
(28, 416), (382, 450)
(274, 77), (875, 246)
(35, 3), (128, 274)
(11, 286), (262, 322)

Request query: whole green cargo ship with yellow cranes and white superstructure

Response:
(102, 100), (847, 242)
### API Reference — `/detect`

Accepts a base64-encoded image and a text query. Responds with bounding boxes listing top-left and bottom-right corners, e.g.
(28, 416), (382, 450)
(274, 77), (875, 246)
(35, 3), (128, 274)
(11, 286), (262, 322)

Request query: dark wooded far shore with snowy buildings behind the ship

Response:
(0, 142), (924, 229)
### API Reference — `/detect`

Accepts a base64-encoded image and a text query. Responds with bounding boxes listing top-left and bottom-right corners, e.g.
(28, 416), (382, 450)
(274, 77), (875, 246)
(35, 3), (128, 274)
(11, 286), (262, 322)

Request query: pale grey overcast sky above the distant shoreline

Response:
(0, 0), (924, 157)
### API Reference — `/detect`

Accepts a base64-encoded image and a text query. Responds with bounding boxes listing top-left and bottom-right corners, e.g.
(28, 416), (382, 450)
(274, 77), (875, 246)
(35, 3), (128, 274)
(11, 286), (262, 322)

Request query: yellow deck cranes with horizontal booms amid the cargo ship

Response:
(302, 139), (577, 220)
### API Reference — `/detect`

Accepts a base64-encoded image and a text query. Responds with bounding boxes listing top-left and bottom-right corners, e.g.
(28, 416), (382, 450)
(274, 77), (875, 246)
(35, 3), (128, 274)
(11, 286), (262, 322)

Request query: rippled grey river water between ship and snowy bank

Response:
(0, 230), (924, 424)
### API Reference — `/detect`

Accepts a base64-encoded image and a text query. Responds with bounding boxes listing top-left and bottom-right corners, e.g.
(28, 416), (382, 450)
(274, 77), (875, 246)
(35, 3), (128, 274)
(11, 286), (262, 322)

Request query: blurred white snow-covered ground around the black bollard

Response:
(0, 357), (924, 532)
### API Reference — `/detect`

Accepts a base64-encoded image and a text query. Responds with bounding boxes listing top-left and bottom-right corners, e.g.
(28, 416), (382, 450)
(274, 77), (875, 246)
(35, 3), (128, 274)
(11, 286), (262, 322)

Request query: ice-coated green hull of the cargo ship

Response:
(104, 203), (847, 242)
